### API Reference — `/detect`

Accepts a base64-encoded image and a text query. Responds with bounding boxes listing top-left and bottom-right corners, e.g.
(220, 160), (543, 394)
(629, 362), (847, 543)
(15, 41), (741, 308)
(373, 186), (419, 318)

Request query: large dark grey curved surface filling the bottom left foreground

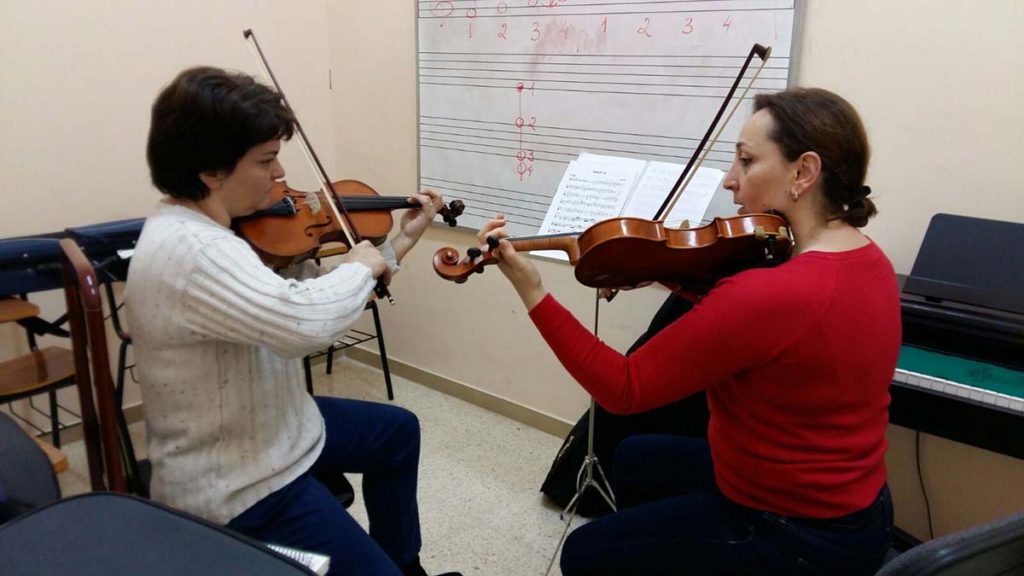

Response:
(0, 492), (312, 576)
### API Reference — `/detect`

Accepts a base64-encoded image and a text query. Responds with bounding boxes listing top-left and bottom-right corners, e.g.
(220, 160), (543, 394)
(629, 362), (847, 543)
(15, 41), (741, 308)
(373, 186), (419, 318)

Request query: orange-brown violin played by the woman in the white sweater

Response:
(231, 180), (465, 270)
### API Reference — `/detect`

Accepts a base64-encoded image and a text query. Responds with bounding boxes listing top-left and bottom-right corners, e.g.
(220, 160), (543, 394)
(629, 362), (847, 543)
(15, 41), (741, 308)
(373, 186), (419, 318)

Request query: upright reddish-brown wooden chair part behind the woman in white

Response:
(60, 238), (129, 493)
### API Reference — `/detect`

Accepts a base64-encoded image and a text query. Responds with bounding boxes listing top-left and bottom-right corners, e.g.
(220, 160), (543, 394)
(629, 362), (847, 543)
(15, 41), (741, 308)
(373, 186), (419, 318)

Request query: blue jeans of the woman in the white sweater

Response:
(227, 398), (421, 576)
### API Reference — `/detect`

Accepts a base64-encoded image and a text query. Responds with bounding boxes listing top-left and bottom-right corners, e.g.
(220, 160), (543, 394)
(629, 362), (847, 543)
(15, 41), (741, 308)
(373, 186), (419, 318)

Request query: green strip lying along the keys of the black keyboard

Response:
(896, 344), (1024, 398)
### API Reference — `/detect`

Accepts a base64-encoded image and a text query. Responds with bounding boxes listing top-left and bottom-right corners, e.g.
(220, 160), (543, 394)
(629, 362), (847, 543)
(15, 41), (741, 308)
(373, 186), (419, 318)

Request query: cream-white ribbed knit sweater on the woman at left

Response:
(126, 205), (397, 523)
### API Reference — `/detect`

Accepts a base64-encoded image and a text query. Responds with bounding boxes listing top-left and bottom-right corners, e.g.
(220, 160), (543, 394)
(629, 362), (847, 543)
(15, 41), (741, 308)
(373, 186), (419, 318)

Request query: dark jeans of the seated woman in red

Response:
(561, 436), (893, 576)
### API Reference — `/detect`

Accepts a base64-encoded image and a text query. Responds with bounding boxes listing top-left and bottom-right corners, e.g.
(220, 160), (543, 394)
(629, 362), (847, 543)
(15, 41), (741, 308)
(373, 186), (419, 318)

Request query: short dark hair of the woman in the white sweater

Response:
(145, 67), (295, 200)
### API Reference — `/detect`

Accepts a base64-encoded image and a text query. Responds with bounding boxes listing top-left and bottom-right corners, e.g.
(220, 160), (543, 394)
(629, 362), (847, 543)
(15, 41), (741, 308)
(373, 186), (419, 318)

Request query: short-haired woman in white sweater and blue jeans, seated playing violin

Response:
(127, 68), (460, 576)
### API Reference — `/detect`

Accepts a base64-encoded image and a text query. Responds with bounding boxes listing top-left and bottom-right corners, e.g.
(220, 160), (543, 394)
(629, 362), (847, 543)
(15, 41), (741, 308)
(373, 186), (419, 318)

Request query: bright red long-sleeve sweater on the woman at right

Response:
(529, 243), (901, 518)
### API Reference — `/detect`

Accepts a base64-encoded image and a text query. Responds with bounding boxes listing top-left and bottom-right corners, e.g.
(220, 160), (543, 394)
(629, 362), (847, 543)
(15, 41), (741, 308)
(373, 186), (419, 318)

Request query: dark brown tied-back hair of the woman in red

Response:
(754, 88), (878, 228)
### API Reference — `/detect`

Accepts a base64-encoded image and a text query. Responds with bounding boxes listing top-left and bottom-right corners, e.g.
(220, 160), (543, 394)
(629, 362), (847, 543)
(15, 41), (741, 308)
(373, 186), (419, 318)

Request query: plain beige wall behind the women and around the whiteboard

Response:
(0, 0), (1024, 535)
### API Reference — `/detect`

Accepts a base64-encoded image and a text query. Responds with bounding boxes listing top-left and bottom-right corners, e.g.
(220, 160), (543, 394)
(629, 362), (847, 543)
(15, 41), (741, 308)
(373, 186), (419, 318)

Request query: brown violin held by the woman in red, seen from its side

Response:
(434, 214), (793, 294)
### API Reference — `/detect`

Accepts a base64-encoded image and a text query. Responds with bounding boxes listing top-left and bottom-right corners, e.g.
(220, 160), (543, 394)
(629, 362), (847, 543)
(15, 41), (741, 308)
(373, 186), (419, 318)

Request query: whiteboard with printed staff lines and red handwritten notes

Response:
(417, 0), (799, 236)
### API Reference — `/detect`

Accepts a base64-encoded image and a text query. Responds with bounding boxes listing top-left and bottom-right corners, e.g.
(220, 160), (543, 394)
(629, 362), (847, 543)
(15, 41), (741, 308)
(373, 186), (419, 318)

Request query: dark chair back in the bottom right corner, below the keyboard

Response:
(876, 511), (1024, 576)
